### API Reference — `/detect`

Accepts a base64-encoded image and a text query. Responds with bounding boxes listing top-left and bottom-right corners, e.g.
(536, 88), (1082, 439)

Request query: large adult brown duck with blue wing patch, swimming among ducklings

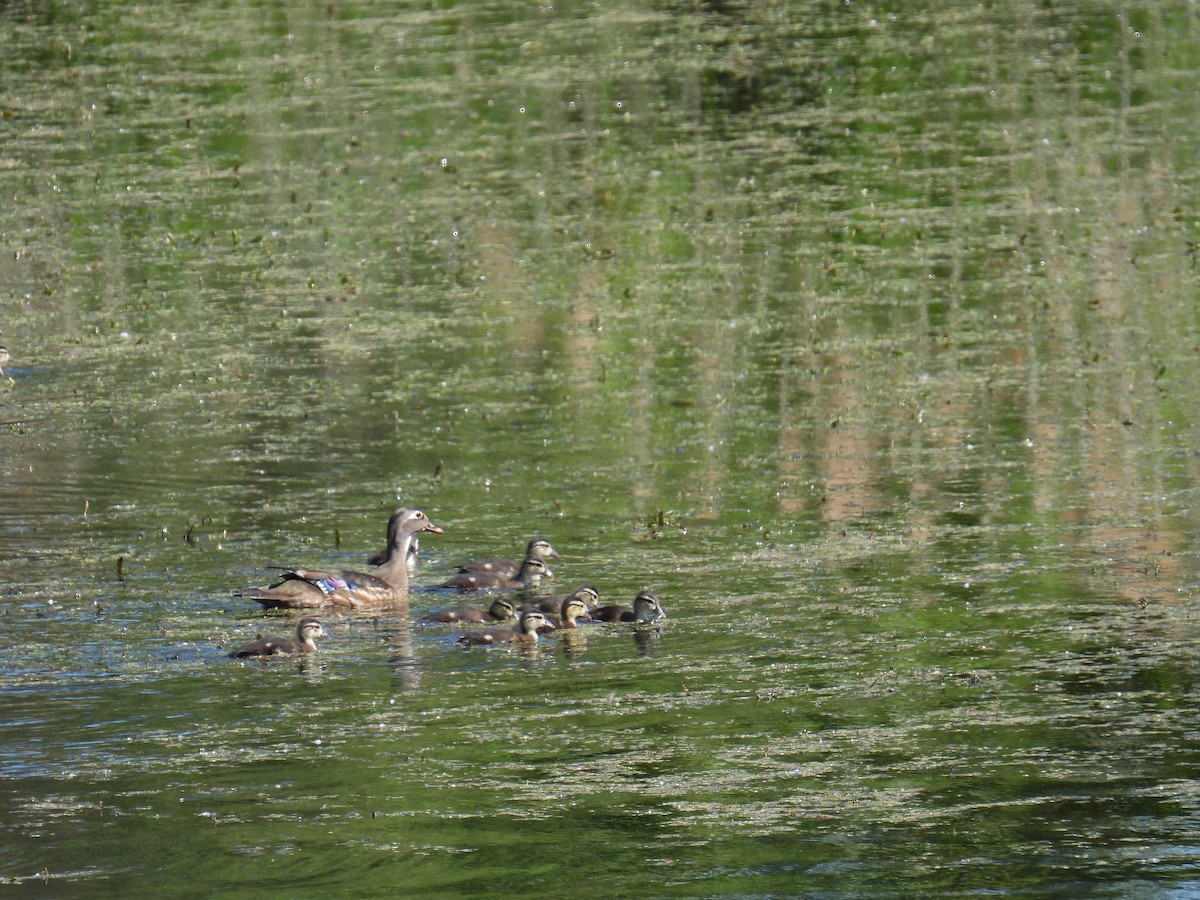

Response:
(234, 509), (442, 610)
